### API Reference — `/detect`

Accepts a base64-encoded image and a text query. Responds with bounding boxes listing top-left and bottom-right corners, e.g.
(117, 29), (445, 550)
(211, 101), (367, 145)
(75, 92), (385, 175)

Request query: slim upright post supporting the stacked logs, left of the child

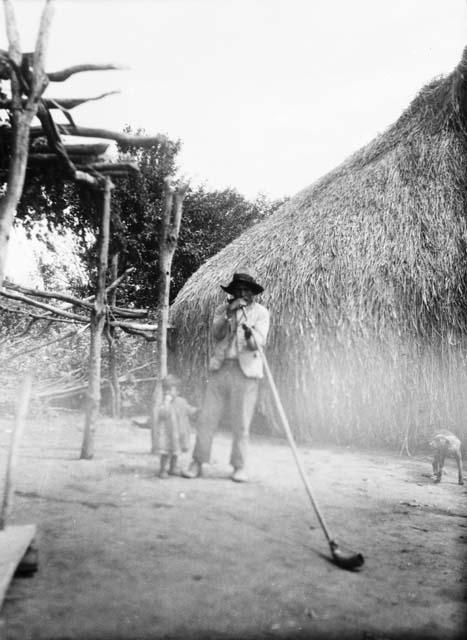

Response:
(80, 178), (113, 460)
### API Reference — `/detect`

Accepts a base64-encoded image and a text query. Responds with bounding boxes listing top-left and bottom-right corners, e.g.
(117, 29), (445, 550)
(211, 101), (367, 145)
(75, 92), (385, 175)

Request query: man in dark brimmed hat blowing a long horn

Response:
(182, 269), (269, 482)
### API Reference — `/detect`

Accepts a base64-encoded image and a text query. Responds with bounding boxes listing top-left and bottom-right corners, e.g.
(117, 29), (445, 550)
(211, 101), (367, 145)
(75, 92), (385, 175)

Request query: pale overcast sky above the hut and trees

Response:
(0, 0), (467, 197)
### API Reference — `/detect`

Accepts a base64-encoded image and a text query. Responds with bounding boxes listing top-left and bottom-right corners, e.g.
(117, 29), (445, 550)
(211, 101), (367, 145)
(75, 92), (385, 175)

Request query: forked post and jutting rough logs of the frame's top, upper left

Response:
(0, 0), (165, 286)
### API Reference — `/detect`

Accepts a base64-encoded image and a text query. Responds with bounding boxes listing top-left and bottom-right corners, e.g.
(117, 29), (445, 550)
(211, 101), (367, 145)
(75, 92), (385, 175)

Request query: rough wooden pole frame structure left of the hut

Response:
(0, 0), (186, 459)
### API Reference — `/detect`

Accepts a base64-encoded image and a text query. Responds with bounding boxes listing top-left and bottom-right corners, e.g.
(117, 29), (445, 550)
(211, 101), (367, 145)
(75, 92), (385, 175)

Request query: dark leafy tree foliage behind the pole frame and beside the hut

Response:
(1, 121), (283, 308)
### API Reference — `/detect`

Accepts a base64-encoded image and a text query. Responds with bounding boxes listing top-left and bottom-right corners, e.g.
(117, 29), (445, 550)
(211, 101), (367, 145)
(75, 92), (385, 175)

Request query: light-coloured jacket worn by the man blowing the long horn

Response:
(209, 302), (269, 378)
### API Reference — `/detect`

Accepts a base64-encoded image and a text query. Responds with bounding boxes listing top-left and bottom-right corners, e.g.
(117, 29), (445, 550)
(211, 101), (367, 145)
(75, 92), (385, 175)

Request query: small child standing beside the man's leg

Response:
(157, 375), (198, 479)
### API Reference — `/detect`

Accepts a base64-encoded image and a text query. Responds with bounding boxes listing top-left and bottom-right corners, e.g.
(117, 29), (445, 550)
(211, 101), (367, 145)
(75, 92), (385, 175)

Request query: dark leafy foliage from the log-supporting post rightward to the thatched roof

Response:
(104, 129), (288, 308)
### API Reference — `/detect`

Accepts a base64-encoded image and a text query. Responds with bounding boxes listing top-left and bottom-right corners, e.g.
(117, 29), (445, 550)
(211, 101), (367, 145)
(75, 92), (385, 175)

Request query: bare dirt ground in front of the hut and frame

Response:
(0, 414), (467, 640)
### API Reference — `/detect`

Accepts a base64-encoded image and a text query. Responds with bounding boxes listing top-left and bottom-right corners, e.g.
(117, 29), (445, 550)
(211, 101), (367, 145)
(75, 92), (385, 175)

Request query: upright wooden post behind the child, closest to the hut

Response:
(151, 178), (188, 453)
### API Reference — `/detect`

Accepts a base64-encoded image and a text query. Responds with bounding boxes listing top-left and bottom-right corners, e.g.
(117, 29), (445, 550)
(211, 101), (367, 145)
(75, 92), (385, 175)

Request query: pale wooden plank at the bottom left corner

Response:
(0, 524), (36, 608)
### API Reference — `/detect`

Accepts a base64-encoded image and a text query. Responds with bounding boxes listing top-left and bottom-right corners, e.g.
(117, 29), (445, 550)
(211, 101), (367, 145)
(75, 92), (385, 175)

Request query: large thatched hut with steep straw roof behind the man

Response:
(172, 48), (467, 445)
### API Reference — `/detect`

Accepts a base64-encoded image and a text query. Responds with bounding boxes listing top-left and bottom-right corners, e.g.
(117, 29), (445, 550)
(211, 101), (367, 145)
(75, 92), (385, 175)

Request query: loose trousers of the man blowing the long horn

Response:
(193, 360), (259, 469)
